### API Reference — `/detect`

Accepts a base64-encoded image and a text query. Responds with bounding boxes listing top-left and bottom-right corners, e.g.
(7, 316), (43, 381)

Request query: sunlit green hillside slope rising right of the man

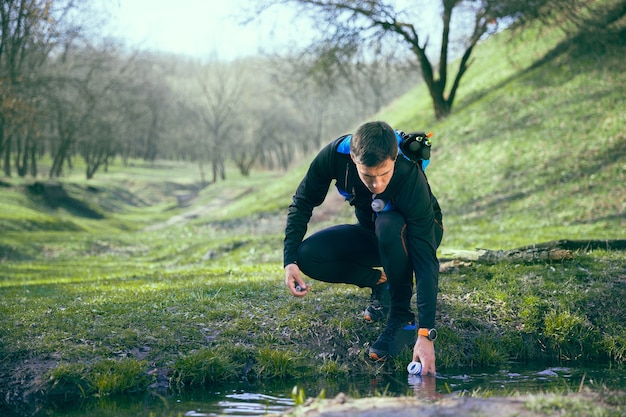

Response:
(377, 26), (626, 249)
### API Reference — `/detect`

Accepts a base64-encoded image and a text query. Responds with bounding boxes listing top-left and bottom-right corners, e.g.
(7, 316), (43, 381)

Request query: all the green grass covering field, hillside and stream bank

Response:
(0, 10), (626, 409)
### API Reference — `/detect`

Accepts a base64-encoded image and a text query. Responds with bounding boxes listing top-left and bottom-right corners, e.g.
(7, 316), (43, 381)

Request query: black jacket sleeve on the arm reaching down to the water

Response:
(396, 166), (442, 328)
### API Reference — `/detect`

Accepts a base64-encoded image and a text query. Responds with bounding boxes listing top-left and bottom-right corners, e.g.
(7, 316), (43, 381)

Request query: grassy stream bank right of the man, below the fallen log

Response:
(438, 252), (626, 365)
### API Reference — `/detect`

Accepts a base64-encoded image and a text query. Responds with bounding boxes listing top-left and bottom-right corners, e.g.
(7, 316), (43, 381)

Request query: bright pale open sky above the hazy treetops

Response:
(109, 0), (312, 60)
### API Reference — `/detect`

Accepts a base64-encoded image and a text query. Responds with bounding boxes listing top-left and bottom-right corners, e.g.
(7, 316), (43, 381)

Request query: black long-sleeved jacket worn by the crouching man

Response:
(284, 136), (443, 328)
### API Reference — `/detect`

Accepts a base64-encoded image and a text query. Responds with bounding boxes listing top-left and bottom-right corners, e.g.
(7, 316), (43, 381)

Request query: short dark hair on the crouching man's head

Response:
(350, 121), (398, 167)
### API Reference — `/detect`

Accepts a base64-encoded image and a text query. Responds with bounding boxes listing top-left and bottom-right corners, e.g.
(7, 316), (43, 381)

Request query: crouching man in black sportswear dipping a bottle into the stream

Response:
(284, 122), (443, 375)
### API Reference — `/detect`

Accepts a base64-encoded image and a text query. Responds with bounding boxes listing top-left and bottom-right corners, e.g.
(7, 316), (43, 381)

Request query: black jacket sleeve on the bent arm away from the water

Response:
(283, 142), (335, 266)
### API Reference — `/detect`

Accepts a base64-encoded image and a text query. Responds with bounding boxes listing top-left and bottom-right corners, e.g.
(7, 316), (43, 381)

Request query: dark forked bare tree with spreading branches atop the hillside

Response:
(260, 0), (596, 119)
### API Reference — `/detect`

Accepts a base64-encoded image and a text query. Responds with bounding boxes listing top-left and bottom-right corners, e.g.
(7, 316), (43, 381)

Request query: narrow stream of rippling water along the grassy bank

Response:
(25, 366), (626, 417)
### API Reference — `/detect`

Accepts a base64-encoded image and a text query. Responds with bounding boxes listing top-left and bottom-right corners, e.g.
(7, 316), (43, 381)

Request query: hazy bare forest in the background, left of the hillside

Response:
(0, 0), (417, 183)
